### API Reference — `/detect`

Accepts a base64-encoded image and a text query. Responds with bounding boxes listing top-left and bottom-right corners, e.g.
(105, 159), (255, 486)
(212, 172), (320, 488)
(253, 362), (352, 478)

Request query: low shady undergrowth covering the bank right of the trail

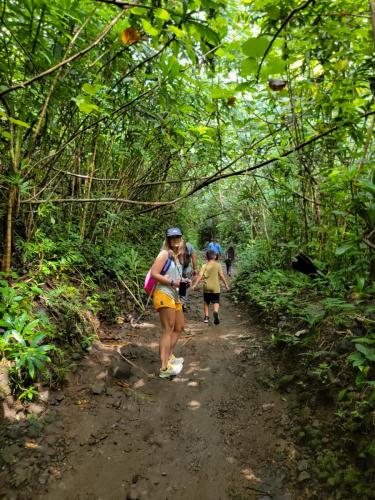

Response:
(232, 241), (375, 499)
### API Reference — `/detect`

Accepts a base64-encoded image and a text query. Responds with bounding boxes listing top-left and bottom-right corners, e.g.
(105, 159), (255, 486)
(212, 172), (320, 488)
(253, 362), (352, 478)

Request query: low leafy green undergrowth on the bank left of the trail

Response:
(0, 232), (151, 399)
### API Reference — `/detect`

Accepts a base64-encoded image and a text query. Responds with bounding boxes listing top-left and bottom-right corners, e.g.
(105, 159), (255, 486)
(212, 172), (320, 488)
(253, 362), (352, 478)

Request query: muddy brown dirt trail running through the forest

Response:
(3, 292), (312, 500)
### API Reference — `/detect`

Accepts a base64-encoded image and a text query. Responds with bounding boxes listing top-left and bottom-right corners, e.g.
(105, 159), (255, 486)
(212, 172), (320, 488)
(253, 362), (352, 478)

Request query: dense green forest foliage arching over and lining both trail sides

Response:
(0, 0), (375, 498)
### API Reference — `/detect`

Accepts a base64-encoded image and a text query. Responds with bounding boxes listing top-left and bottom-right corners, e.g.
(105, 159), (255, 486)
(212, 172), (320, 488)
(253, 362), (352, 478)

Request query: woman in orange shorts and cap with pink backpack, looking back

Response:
(151, 227), (190, 378)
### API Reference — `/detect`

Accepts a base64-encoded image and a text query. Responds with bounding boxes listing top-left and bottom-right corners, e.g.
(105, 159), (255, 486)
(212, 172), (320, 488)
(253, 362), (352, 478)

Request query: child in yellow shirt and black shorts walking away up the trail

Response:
(192, 250), (229, 325)
